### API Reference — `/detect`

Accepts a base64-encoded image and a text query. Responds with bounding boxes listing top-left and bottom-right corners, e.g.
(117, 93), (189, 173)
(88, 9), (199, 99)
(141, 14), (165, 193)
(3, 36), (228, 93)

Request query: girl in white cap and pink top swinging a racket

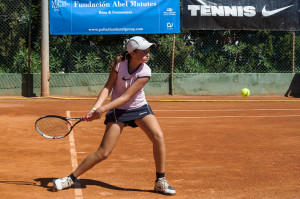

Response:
(53, 36), (176, 195)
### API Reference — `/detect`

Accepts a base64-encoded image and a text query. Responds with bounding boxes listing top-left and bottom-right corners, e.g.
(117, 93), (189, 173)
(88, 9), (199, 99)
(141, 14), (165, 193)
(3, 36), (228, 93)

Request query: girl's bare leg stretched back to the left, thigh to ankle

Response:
(73, 123), (124, 178)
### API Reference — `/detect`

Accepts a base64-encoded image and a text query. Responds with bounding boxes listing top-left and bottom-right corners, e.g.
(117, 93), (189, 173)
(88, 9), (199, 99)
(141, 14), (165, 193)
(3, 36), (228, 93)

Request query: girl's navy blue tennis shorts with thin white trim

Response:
(104, 104), (154, 128)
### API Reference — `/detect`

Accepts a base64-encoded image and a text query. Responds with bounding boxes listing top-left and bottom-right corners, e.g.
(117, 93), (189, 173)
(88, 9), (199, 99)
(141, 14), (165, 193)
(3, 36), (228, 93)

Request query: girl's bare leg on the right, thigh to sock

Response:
(135, 115), (166, 173)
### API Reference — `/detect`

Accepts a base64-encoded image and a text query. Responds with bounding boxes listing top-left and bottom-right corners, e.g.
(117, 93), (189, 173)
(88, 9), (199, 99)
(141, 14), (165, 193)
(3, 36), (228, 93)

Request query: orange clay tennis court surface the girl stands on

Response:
(0, 96), (300, 199)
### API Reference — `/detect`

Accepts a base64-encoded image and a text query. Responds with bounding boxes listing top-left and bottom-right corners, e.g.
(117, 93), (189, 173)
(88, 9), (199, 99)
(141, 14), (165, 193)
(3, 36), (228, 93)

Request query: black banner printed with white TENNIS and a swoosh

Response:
(181, 0), (300, 31)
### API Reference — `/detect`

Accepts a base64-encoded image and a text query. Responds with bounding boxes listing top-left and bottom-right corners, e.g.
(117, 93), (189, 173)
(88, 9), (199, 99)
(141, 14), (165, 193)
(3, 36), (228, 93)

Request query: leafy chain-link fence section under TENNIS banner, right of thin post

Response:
(174, 31), (300, 73)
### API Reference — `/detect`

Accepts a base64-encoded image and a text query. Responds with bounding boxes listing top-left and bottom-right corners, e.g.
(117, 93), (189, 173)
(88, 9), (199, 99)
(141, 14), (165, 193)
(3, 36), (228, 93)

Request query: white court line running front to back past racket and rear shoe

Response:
(67, 111), (83, 199)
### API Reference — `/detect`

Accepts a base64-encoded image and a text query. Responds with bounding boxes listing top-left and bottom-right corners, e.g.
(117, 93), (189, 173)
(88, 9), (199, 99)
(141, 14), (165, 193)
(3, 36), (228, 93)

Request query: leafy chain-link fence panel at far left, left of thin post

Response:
(0, 0), (30, 73)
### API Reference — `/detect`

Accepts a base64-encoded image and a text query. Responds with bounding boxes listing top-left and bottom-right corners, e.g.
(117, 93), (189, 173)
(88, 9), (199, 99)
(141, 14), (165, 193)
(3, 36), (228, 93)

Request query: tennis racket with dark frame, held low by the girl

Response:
(35, 115), (86, 139)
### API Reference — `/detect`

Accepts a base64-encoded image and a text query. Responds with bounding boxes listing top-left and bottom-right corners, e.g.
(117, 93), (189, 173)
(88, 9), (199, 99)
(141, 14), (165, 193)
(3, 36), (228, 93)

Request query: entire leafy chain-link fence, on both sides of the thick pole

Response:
(0, 0), (300, 82)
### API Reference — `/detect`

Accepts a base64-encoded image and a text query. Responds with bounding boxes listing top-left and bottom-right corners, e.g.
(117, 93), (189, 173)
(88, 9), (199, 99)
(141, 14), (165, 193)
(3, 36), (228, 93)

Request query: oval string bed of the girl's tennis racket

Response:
(36, 117), (72, 137)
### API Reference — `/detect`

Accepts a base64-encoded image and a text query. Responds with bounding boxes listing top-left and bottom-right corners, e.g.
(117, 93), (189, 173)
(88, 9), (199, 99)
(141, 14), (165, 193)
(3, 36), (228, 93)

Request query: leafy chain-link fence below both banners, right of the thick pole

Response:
(43, 31), (300, 73)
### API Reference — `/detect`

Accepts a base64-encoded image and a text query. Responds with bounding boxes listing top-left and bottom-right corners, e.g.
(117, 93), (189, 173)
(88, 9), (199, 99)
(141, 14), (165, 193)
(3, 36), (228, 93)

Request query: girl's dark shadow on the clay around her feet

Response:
(34, 178), (155, 193)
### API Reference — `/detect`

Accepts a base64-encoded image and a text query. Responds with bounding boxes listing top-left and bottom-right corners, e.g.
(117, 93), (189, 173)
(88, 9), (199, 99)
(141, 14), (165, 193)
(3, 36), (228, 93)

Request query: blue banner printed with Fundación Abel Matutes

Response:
(49, 0), (180, 35)
